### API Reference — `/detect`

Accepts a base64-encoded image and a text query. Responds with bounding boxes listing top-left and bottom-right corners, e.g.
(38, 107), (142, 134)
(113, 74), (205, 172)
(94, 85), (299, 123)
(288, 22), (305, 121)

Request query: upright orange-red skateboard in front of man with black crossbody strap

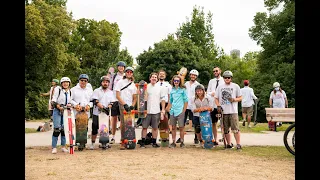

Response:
(120, 110), (138, 149)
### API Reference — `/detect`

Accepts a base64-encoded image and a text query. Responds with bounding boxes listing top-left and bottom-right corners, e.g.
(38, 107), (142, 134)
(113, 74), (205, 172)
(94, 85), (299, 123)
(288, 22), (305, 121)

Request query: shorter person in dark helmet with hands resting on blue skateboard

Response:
(191, 84), (213, 147)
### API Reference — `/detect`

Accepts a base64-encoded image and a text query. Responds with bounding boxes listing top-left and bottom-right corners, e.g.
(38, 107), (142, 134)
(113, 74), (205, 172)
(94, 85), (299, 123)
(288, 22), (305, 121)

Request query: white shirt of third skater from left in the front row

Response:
(90, 86), (114, 116)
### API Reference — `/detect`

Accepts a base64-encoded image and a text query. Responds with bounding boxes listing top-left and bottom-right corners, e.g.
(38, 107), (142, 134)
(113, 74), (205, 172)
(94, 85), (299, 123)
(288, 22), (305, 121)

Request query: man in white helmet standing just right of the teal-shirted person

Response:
(176, 69), (200, 144)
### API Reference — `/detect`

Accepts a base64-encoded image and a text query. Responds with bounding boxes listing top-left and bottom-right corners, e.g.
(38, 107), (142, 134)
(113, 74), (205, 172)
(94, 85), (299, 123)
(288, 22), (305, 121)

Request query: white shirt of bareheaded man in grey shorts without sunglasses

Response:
(147, 83), (168, 114)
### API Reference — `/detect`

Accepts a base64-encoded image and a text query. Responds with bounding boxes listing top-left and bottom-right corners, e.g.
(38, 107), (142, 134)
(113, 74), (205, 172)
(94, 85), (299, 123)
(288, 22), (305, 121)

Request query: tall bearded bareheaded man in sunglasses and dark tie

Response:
(207, 66), (224, 146)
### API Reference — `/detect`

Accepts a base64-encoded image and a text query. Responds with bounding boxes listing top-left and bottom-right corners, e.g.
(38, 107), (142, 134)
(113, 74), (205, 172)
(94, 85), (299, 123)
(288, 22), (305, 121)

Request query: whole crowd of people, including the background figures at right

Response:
(41, 61), (288, 153)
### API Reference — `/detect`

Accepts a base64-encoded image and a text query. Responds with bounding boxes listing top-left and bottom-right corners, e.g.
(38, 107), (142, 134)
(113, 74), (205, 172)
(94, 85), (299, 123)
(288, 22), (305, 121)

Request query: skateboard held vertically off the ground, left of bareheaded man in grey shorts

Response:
(136, 80), (147, 118)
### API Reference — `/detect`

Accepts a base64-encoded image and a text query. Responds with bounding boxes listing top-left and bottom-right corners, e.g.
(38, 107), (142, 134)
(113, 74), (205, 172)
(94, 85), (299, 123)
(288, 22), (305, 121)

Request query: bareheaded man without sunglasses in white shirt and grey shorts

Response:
(140, 73), (168, 148)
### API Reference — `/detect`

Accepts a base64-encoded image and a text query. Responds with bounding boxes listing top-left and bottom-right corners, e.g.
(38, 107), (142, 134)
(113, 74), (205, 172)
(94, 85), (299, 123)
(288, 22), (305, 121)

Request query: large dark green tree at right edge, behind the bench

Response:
(249, 0), (295, 119)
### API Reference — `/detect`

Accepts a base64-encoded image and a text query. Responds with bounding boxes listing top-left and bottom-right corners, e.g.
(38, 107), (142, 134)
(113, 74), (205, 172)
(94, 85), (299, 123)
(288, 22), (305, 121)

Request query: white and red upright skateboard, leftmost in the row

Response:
(63, 106), (76, 154)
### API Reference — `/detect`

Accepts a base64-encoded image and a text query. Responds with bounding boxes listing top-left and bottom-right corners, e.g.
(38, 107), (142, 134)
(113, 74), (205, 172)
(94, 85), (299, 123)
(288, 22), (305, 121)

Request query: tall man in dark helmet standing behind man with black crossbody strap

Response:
(109, 61), (126, 144)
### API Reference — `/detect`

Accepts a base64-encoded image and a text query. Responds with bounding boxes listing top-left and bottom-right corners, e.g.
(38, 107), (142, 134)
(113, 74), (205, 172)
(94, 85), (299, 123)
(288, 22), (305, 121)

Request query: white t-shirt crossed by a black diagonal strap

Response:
(115, 78), (137, 106)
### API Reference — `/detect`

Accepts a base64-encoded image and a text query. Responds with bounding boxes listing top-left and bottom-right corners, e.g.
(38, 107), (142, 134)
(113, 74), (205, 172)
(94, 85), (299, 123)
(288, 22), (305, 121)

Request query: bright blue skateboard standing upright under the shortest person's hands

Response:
(200, 111), (214, 149)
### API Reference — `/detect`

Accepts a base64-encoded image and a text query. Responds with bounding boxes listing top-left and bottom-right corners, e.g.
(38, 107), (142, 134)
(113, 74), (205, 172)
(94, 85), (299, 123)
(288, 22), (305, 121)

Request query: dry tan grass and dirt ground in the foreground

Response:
(25, 145), (295, 180)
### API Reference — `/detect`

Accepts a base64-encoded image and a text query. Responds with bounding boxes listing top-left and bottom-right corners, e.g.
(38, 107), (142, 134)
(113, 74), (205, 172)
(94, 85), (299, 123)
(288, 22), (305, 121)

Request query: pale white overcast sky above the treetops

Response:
(67, 0), (267, 59)
